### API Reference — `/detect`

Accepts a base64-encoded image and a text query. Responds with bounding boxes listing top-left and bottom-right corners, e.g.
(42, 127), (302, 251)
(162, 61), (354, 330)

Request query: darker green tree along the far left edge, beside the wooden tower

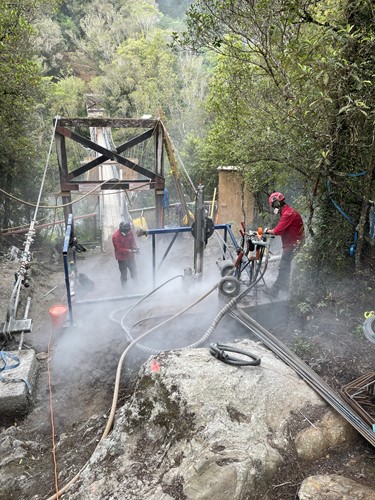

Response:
(0, 0), (58, 229)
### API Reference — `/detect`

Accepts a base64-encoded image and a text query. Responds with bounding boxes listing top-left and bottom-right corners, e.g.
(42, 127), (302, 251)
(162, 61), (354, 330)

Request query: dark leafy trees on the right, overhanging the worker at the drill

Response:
(176, 0), (375, 269)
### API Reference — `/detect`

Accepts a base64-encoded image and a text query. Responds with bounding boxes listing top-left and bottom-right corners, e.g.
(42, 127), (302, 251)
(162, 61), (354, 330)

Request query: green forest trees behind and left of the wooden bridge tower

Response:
(0, 0), (207, 235)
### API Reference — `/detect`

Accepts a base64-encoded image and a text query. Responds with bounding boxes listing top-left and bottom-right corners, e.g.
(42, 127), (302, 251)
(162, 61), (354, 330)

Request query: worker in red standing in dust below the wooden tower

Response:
(112, 222), (139, 287)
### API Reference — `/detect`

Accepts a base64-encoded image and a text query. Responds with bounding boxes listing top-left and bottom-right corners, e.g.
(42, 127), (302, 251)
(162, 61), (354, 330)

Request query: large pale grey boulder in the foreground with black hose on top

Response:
(66, 341), (356, 500)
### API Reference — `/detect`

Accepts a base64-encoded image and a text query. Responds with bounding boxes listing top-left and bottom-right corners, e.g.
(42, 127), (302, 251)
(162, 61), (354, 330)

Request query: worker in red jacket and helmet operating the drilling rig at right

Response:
(265, 192), (304, 297)
